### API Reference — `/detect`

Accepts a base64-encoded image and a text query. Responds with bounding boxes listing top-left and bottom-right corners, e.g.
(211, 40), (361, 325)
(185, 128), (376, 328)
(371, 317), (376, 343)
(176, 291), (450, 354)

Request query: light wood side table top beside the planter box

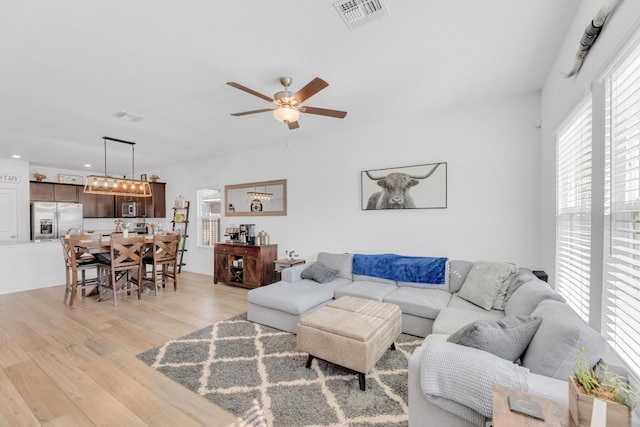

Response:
(493, 385), (575, 427)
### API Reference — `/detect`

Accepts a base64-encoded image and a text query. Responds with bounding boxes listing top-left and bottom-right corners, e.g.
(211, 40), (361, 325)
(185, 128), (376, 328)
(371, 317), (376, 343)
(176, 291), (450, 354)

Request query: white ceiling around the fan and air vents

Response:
(0, 0), (580, 175)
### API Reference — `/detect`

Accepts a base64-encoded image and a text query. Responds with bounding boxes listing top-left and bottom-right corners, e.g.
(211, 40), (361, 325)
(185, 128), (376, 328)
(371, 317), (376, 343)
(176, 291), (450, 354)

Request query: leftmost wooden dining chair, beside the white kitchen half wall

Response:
(60, 235), (108, 307)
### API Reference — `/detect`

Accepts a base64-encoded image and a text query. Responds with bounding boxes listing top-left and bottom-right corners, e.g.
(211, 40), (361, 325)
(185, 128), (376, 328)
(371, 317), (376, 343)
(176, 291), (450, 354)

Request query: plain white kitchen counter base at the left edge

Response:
(0, 240), (66, 298)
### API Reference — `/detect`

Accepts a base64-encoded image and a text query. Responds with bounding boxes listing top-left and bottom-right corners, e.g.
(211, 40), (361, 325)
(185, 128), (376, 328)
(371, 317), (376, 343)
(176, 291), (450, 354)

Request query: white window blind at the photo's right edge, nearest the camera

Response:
(602, 40), (640, 377)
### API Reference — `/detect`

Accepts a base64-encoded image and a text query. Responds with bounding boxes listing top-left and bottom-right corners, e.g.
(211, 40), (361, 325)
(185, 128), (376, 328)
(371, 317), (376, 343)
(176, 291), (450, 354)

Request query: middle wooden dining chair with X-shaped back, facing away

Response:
(110, 235), (144, 306)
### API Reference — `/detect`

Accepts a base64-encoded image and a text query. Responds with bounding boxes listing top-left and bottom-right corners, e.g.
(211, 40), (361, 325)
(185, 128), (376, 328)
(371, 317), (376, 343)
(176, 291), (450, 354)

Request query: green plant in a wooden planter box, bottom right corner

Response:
(569, 348), (640, 427)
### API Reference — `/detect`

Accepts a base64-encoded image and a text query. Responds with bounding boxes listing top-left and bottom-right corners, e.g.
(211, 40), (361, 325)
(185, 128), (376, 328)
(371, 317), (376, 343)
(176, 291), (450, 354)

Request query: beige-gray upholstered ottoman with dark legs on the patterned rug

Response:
(297, 296), (402, 390)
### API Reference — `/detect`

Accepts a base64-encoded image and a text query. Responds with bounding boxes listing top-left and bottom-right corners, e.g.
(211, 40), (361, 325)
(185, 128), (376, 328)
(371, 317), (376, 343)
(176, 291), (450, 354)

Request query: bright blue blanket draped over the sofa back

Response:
(353, 254), (447, 284)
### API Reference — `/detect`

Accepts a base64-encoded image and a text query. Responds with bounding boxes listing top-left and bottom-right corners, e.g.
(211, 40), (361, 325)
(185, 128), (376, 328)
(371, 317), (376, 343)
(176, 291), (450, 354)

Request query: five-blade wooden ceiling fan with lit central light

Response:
(227, 77), (347, 129)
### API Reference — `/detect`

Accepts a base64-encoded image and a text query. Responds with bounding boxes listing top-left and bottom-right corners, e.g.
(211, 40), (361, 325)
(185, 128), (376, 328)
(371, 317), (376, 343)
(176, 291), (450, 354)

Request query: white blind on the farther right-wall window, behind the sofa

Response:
(556, 96), (592, 321)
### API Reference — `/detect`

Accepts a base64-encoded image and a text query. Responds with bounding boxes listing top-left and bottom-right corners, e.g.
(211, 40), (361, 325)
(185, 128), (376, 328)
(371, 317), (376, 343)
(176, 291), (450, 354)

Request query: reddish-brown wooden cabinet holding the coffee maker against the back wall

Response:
(213, 243), (278, 288)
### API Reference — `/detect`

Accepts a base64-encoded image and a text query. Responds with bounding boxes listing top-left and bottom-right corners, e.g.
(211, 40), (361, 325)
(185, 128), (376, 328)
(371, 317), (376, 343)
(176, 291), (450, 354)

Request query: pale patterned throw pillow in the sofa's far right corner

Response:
(458, 261), (518, 310)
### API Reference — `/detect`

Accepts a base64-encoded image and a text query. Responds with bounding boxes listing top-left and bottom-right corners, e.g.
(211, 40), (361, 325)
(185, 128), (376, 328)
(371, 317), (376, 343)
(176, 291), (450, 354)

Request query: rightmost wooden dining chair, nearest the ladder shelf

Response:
(143, 233), (180, 295)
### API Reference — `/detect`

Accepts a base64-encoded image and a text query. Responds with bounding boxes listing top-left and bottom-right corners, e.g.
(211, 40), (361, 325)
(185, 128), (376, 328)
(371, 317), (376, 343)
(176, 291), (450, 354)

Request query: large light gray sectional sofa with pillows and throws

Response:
(247, 253), (618, 427)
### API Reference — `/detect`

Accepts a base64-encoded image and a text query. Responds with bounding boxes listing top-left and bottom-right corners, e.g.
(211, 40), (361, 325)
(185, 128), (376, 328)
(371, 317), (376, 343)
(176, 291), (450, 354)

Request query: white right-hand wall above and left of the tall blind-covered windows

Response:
(540, 1), (640, 282)
